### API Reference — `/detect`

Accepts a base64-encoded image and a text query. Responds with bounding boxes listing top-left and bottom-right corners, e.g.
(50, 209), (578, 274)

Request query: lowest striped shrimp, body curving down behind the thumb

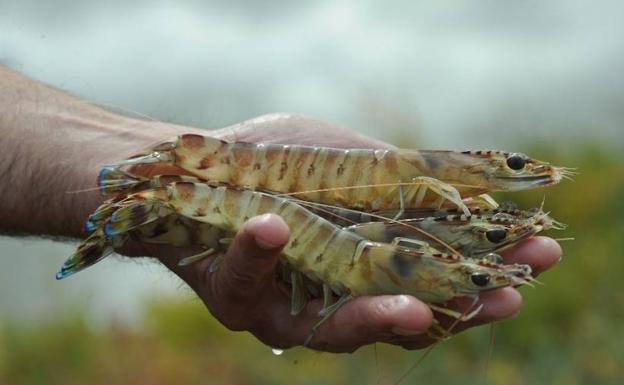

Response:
(58, 182), (532, 330)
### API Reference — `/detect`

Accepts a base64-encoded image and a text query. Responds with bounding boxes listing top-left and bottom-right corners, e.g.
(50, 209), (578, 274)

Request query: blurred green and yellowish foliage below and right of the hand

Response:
(0, 143), (624, 385)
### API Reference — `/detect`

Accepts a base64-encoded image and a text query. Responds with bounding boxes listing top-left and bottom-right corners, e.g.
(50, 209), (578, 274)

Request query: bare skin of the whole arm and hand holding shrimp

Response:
(0, 67), (561, 352)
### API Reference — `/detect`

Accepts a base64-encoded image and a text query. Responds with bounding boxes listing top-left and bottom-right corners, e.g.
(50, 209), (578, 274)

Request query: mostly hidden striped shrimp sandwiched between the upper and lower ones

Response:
(91, 168), (555, 257)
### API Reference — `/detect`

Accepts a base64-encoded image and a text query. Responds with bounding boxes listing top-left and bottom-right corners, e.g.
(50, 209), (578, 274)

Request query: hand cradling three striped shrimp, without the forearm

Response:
(130, 114), (561, 352)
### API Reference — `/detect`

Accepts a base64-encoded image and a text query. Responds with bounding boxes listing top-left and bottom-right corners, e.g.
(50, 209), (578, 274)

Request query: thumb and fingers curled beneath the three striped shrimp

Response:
(166, 215), (561, 352)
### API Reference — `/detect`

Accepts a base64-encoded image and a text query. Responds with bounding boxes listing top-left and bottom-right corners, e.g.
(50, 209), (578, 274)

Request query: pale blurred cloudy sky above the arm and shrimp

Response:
(0, 0), (624, 146)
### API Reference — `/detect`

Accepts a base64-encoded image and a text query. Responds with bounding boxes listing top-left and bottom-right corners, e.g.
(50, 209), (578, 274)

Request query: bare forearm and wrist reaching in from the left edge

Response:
(0, 67), (190, 236)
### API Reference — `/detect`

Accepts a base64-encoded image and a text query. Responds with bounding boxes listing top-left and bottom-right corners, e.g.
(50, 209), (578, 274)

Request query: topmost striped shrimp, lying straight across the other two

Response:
(100, 134), (571, 215)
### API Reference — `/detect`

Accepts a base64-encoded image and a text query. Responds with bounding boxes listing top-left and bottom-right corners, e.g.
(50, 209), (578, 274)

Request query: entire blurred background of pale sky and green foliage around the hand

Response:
(0, 0), (624, 385)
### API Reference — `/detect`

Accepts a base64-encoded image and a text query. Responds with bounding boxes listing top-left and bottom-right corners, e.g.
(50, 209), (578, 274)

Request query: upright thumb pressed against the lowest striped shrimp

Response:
(215, 214), (290, 305)
